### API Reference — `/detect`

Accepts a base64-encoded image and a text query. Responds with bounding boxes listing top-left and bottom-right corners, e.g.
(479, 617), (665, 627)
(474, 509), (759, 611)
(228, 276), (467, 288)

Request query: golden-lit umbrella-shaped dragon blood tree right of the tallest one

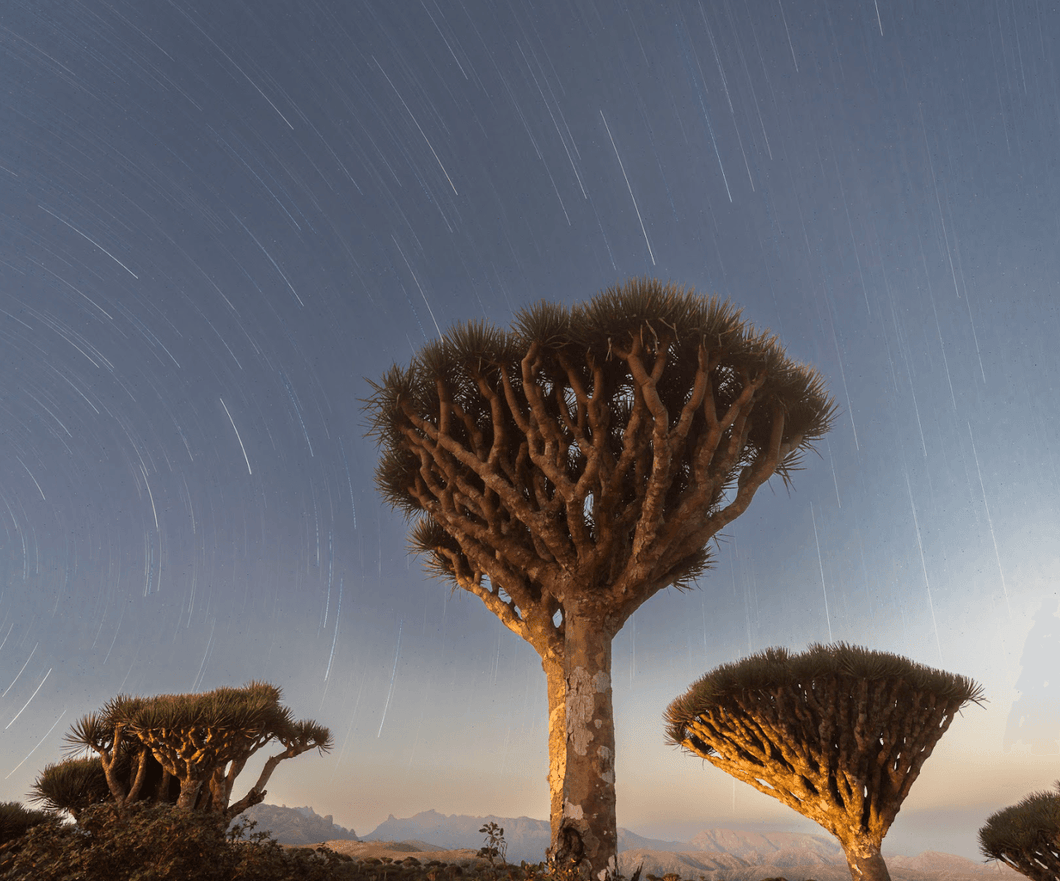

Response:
(666, 642), (983, 881)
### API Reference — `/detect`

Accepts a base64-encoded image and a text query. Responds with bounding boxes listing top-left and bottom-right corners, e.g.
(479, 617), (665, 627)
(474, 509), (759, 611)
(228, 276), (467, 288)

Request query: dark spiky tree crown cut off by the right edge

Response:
(979, 780), (1060, 881)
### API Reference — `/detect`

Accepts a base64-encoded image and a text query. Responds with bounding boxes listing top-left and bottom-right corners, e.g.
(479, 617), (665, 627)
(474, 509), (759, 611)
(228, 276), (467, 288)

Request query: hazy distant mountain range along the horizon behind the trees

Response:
(247, 805), (1022, 881)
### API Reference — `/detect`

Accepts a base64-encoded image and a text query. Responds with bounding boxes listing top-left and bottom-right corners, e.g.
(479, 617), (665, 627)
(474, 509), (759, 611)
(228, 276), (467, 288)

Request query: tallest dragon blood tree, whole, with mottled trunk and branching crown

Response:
(366, 280), (833, 876)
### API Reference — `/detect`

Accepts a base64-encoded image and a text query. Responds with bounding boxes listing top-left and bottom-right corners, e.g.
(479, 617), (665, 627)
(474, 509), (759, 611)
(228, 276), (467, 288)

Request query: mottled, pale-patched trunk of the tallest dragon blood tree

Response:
(552, 610), (618, 879)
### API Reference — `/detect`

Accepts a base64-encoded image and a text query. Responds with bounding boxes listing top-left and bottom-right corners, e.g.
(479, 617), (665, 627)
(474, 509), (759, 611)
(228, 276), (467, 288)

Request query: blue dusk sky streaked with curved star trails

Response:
(0, 0), (1060, 858)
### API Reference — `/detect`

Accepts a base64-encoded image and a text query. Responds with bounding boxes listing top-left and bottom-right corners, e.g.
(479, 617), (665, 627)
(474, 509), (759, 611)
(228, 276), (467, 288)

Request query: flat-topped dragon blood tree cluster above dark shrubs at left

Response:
(42, 682), (332, 825)
